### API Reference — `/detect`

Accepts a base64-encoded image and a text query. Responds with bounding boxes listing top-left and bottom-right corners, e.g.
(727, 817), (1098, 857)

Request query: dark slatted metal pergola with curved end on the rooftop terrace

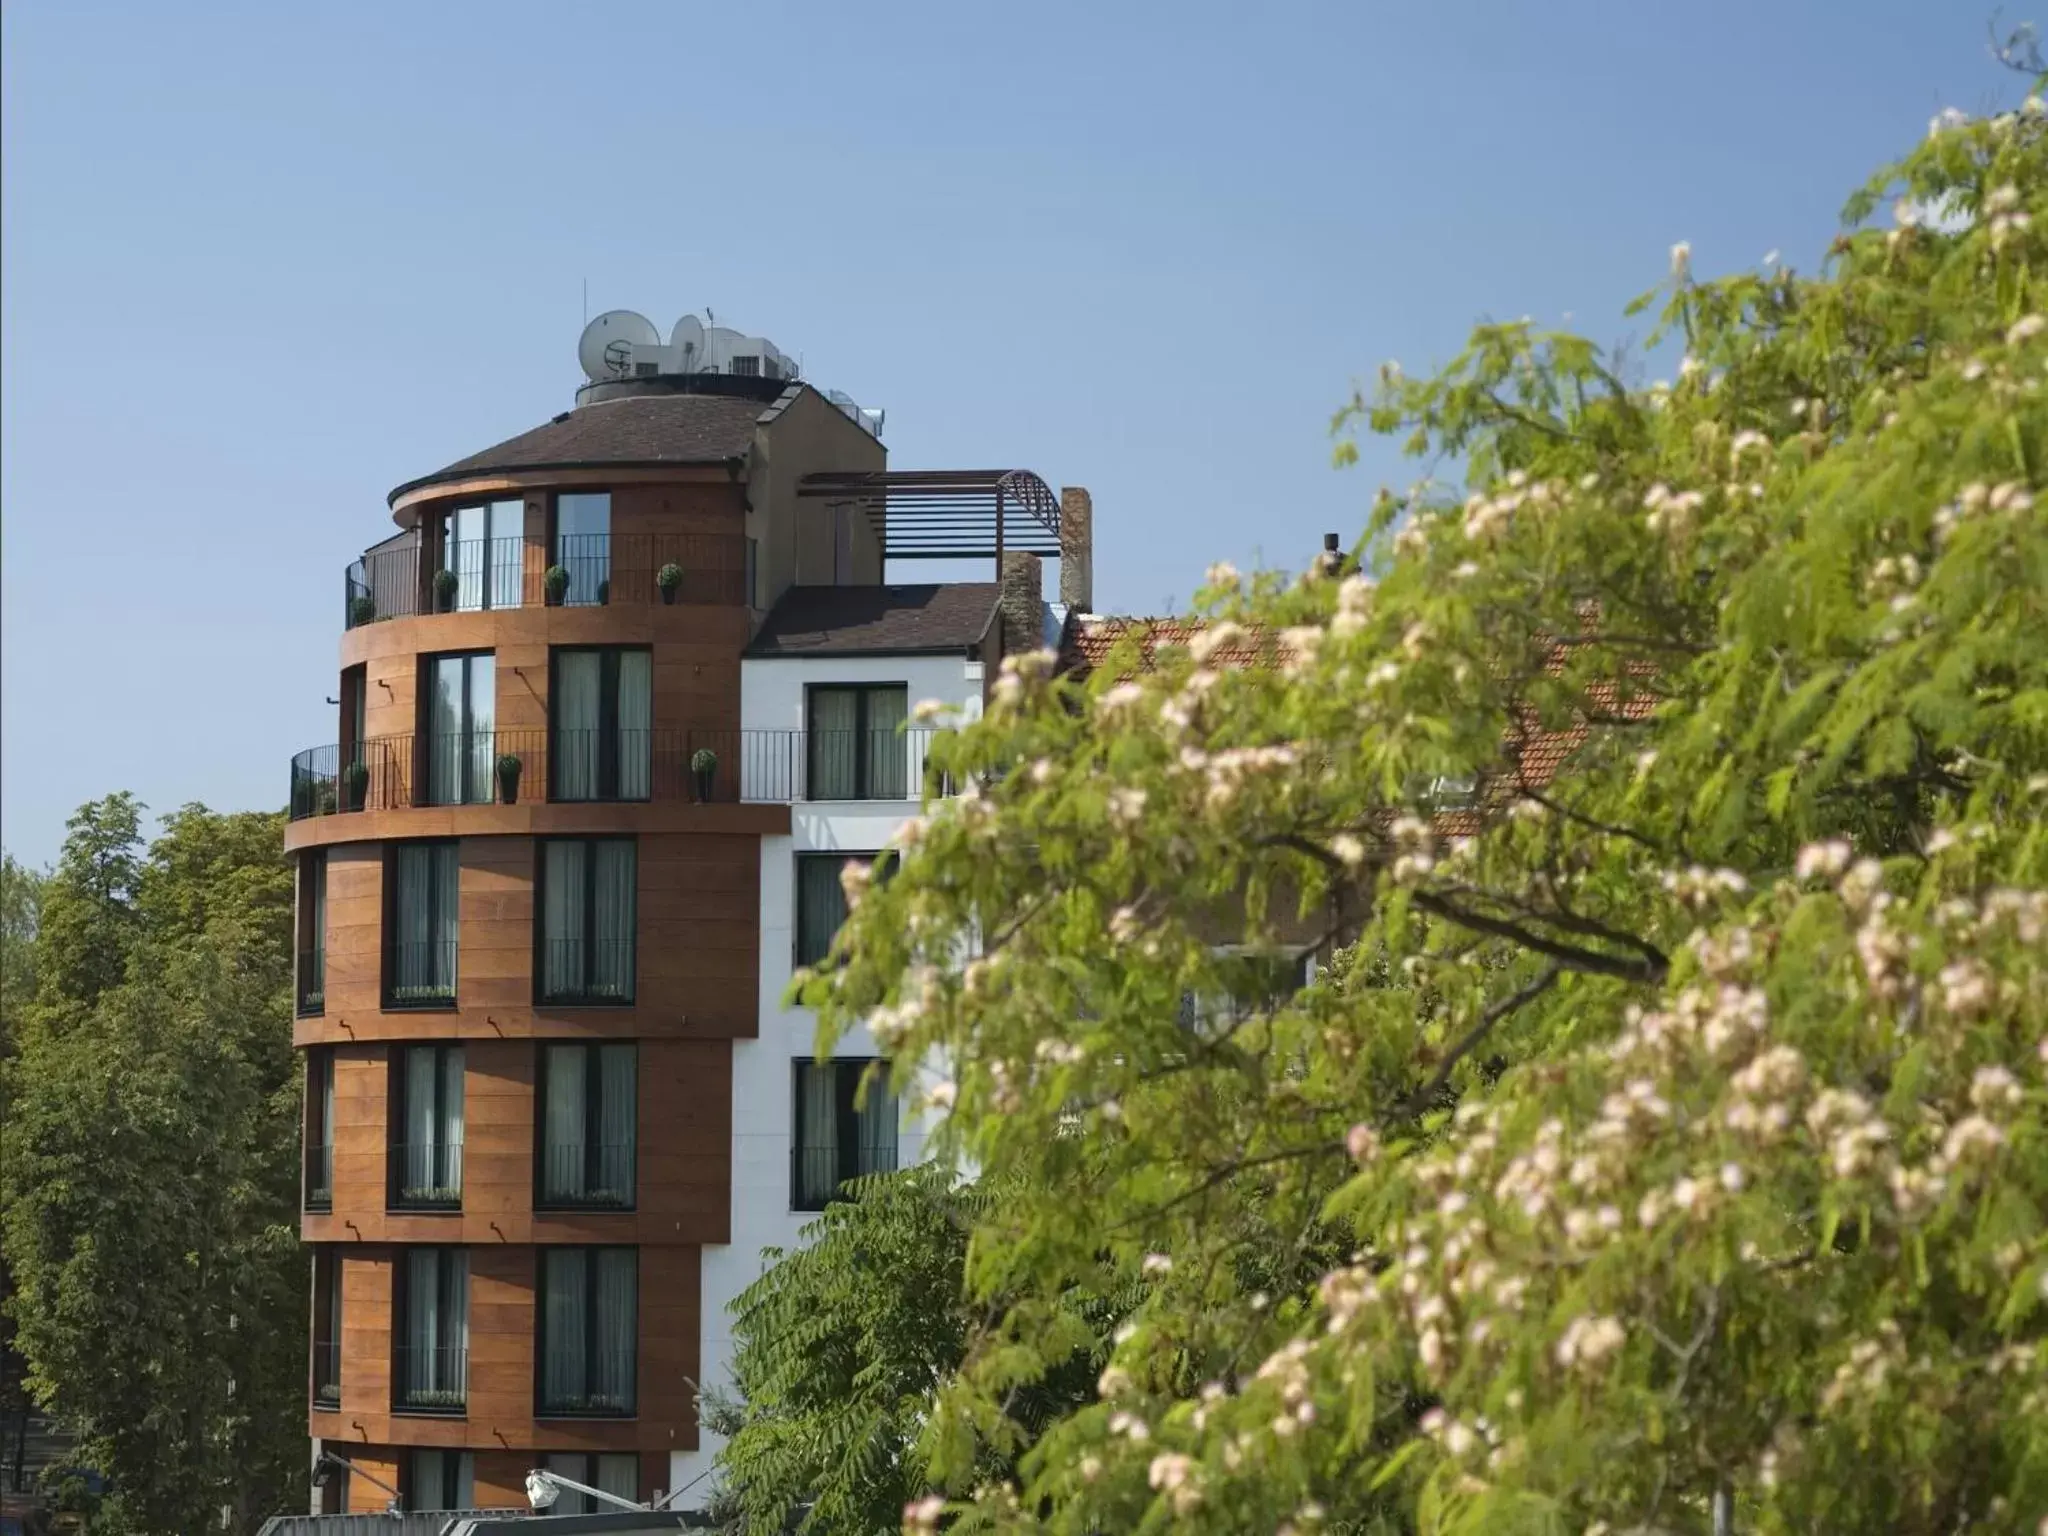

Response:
(797, 469), (1059, 573)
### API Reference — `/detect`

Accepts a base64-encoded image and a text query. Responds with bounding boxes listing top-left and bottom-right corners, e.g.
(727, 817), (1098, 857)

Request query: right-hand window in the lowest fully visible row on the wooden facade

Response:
(539, 1247), (639, 1417)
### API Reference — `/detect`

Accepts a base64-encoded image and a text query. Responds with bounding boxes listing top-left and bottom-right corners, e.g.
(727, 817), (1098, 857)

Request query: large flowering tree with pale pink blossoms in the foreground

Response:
(805, 98), (2048, 1534)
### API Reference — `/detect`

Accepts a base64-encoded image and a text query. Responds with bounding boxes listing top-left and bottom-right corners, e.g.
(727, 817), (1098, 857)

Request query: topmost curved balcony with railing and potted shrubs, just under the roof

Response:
(342, 535), (750, 629)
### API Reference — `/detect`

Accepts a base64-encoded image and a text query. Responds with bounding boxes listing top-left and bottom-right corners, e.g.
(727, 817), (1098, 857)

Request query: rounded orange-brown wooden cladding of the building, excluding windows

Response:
(303, 467), (788, 1509)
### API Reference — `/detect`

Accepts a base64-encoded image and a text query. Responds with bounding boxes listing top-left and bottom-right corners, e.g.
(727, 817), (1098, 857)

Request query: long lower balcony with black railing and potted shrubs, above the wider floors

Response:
(289, 727), (944, 821)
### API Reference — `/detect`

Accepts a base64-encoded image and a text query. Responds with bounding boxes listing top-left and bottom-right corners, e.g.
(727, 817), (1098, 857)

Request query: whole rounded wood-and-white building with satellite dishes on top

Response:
(287, 313), (1090, 1513)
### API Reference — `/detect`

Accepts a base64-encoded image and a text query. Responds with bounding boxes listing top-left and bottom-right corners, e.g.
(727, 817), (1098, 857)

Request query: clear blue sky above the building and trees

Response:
(0, 0), (2019, 862)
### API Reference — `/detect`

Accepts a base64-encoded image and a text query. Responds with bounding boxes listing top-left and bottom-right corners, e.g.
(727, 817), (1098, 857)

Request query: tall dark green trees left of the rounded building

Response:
(0, 795), (305, 1536)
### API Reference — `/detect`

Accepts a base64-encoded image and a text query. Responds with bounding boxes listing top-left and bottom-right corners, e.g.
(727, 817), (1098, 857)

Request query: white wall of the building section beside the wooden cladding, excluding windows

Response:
(668, 653), (983, 1507)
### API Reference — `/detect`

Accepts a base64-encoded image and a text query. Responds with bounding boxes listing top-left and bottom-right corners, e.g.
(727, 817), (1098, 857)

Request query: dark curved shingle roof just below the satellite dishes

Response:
(389, 385), (778, 502)
